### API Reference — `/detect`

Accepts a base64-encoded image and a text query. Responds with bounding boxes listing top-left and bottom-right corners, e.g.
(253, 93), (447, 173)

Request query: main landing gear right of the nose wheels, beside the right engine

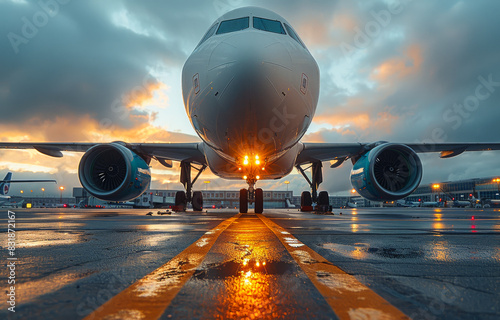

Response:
(296, 161), (330, 212)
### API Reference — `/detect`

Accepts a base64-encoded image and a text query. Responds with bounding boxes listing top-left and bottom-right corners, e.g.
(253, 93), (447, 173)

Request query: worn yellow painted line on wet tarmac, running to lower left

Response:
(84, 213), (241, 320)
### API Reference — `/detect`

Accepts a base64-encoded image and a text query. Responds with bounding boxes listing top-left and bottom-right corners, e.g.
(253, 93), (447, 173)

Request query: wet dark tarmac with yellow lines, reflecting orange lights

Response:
(0, 208), (500, 319)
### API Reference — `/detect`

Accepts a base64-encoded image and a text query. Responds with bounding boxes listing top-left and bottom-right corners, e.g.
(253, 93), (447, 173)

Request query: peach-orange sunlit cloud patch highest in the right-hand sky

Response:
(371, 45), (422, 82)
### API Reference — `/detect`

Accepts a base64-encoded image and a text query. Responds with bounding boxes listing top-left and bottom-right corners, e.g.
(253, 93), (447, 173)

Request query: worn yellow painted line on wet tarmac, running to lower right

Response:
(257, 214), (410, 320)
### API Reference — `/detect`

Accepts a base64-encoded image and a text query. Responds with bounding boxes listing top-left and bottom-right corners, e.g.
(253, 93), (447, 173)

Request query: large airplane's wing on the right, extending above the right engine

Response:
(295, 143), (500, 167)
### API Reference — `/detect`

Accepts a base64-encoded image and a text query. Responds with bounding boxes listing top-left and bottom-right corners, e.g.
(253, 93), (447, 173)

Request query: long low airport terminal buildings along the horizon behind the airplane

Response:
(7, 177), (500, 209)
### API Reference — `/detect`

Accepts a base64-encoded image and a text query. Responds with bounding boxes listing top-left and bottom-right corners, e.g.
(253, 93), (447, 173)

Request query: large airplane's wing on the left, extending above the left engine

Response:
(0, 142), (206, 164)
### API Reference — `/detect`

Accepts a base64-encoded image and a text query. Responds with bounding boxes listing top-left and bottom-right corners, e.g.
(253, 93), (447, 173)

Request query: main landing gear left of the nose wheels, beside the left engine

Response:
(175, 161), (207, 211)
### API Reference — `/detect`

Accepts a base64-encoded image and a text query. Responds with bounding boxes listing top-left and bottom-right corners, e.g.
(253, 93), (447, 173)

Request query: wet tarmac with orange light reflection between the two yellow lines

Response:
(162, 214), (335, 319)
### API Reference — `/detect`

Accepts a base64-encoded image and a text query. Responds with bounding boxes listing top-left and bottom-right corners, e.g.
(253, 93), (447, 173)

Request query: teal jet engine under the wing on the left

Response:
(78, 143), (151, 201)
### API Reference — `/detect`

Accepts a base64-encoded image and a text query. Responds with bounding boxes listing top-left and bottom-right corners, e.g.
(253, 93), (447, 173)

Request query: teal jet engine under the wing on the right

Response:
(351, 143), (423, 201)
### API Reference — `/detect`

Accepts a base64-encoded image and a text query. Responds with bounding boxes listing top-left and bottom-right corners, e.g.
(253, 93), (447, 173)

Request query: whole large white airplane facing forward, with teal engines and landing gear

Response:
(0, 7), (500, 213)
